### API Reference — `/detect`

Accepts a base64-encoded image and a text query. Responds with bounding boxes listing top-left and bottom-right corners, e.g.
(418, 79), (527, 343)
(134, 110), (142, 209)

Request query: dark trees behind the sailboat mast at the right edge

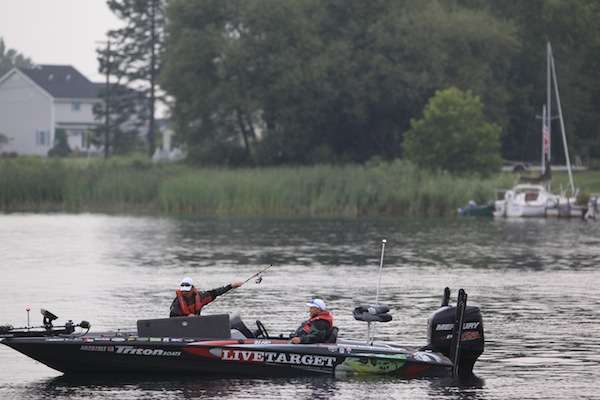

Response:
(458, 0), (600, 162)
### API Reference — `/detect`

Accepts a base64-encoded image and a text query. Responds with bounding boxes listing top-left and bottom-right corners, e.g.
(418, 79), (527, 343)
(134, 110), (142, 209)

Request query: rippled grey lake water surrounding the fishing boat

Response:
(0, 214), (600, 400)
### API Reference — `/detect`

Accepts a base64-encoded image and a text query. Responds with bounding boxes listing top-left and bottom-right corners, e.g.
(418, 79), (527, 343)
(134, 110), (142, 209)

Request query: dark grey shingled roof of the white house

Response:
(19, 65), (98, 99)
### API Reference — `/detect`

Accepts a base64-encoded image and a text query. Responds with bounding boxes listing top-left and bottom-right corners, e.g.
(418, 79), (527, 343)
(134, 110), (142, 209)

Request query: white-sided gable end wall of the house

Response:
(0, 71), (54, 155)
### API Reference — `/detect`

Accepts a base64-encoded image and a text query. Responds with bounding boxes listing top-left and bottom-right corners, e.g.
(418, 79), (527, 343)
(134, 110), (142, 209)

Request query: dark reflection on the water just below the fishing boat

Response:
(28, 375), (485, 400)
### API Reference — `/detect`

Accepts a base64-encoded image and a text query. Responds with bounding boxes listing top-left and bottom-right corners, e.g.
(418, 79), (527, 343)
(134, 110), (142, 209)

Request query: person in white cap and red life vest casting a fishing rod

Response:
(169, 277), (242, 317)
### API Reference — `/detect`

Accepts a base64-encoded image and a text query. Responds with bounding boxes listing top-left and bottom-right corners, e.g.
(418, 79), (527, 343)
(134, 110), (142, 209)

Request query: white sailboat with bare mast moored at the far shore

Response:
(494, 42), (582, 218)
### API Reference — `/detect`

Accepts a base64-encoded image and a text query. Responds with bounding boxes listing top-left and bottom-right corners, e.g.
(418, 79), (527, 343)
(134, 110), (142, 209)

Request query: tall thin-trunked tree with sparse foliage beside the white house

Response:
(97, 0), (166, 156)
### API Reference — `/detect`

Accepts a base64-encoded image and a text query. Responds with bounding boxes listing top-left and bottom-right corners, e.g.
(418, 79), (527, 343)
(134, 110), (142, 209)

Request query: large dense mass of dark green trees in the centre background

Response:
(162, 0), (518, 163)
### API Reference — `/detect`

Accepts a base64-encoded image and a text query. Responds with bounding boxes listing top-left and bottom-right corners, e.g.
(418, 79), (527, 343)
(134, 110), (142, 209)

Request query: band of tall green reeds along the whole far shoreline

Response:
(0, 157), (600, 218)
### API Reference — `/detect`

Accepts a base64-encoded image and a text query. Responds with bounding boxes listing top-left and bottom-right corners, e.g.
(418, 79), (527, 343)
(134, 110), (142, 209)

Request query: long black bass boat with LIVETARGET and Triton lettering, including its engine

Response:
(0, 288), (484, 378)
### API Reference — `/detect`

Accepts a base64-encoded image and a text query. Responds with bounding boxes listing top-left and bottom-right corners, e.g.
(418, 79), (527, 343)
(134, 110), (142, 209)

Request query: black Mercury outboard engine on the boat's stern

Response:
(427, 288), (484, 377)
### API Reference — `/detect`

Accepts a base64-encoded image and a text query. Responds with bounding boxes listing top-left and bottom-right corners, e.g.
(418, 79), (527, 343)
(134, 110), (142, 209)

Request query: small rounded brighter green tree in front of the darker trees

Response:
(404, 87), (502, 174)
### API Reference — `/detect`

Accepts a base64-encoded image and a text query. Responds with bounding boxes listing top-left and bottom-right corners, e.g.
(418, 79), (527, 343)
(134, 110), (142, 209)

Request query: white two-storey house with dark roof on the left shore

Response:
(0, 65), (101, 156)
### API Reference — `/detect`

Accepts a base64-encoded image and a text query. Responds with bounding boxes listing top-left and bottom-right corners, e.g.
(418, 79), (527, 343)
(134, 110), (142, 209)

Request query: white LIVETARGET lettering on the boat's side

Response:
(221, 349), (336, 367)
